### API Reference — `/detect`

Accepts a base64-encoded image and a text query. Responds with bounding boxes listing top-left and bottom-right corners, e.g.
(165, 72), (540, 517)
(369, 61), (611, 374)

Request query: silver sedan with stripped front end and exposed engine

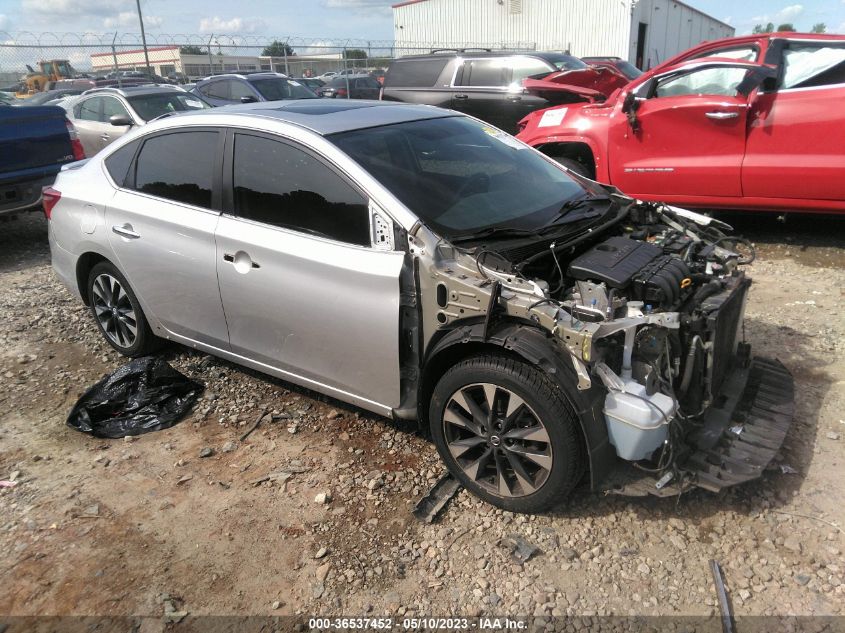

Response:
(45, 100), (793, 512)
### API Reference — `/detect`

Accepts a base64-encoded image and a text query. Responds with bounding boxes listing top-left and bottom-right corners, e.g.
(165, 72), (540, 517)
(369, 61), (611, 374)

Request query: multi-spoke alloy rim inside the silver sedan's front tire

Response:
(443, 383), (553, 497)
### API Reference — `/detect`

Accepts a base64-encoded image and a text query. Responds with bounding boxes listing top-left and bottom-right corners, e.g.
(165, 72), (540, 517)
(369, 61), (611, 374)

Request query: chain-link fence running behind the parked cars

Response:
(0, 31), (535, 97)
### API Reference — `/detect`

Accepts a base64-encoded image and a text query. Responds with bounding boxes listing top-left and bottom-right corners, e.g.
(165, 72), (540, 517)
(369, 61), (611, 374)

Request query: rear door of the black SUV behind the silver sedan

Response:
(452, 57), (509, 129)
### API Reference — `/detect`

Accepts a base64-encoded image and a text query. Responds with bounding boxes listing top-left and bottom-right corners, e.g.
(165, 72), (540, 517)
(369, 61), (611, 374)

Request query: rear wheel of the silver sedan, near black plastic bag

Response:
(88, 262), (159, 358)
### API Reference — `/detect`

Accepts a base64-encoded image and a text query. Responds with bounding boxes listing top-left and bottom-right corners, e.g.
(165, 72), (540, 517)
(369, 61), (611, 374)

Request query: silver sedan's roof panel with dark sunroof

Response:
(152, 99), (454, 136)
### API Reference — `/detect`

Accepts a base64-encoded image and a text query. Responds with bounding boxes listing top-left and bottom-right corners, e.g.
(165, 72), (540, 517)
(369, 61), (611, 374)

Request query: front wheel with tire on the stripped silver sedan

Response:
(429, 355), (585, 513)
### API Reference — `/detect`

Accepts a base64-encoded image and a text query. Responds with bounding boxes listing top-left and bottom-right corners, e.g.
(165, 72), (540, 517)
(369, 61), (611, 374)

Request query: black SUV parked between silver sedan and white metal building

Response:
(382, 49), (588, 133)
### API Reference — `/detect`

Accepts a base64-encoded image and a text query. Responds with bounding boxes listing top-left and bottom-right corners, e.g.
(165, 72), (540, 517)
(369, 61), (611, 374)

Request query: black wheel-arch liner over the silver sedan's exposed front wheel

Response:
(420, 320), (616, 490)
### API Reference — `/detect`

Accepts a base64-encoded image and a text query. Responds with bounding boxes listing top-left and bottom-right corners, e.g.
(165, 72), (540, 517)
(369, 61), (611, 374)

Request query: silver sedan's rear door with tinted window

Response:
(106, 128), (229, 350)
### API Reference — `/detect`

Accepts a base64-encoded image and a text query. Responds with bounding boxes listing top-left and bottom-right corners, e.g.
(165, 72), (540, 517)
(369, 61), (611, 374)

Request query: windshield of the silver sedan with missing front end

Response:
(328, 117), (600, 237)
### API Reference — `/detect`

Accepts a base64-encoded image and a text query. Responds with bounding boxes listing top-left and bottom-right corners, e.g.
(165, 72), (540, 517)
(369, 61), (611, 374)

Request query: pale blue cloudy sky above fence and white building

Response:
(0, 0), (845, 40)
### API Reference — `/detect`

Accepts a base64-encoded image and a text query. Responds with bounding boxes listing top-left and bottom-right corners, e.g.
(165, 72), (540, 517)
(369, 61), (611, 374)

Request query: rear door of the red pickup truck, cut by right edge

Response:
(742, 40), (845, 200)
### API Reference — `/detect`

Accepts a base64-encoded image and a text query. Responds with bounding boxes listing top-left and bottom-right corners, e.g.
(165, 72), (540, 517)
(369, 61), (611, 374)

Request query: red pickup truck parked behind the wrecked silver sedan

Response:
(517, 33), (845, 213)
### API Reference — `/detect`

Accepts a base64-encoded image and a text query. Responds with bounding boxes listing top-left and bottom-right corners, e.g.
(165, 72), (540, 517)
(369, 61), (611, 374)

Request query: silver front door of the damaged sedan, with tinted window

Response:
(217, 132), (404, 407)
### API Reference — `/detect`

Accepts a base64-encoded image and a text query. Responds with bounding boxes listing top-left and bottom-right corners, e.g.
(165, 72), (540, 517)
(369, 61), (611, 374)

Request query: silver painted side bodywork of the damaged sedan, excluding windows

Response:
(49, 109), (454, 415)
